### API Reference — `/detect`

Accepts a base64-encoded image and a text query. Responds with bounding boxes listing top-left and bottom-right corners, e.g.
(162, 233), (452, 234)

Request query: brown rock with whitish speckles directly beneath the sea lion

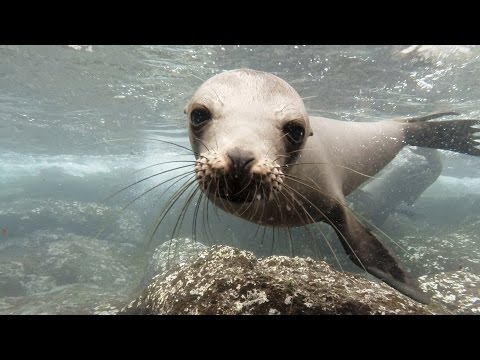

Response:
(120, 246), (431, 314)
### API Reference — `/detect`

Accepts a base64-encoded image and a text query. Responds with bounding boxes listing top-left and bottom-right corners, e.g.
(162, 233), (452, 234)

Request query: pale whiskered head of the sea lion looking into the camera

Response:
(185, 69), (312, 203)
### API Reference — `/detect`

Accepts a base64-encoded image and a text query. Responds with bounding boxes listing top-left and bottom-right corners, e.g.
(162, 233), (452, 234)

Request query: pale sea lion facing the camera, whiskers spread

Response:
(185, 69), (480, 303)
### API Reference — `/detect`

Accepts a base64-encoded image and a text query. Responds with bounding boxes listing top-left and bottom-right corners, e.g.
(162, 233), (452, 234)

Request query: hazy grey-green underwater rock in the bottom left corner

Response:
(0, 229), (143, 314)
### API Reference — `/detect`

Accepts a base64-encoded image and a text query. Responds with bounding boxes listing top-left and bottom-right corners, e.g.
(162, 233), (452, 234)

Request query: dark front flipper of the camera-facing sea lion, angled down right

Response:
(329, 206), (430, 304)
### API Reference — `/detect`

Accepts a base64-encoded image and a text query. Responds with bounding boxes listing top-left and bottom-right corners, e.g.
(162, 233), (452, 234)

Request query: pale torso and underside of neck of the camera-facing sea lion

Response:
(211, 117), (404, 227)
